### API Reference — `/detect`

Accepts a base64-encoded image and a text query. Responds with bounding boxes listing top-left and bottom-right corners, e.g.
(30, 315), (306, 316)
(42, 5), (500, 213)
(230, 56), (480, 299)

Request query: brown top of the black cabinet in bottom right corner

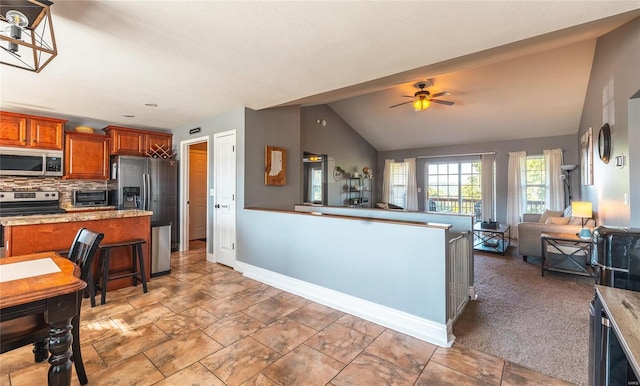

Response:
(596, 285), (640, 376)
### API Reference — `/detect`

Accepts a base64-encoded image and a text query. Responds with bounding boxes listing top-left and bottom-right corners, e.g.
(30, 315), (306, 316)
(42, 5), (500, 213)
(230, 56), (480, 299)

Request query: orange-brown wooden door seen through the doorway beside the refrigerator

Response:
(189, 147), (207, 240)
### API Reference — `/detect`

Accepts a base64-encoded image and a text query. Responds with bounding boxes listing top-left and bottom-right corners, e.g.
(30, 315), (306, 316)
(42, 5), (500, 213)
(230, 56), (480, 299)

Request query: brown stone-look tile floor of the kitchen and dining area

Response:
(0, 242), (567, 386)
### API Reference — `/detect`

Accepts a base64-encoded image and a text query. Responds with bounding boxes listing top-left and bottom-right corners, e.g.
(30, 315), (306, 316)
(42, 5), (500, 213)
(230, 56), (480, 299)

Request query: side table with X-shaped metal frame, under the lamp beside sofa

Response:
(540, 233), (594, 276)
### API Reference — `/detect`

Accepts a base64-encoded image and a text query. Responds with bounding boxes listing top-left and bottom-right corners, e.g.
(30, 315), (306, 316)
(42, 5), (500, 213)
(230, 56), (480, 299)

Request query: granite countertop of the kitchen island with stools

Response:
(0, 209), (153, 226)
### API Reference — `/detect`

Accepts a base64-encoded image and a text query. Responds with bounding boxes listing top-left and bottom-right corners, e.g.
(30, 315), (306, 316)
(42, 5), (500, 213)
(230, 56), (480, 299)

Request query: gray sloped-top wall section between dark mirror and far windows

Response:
(298, 105), (379, 206)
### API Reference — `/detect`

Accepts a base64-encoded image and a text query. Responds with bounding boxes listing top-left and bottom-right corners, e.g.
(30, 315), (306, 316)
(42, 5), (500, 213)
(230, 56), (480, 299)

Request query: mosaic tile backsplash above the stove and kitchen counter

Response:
(0, 177), (107, 206)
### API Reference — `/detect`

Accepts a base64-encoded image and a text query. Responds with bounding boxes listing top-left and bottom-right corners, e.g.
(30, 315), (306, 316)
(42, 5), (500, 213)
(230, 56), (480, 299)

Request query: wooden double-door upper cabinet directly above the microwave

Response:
(0, 111), (67, 150)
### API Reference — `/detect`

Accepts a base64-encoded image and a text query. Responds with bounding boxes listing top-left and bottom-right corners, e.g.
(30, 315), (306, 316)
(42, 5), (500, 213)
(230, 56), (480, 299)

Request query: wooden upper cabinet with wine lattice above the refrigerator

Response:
(102, 126), (173, 157)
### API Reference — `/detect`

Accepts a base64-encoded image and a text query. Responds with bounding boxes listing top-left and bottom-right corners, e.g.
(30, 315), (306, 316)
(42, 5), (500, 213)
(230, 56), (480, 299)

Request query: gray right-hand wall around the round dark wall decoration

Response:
(578, 18), (640, 226)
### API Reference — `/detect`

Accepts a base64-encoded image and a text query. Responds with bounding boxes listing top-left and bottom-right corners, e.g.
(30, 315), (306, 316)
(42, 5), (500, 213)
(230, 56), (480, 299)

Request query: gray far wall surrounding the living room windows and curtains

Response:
(376, 135), (580, 222)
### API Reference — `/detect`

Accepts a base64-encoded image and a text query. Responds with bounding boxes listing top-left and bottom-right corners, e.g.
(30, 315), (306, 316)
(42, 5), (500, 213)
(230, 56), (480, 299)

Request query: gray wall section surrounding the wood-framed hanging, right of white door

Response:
(244, 107), (302, 210)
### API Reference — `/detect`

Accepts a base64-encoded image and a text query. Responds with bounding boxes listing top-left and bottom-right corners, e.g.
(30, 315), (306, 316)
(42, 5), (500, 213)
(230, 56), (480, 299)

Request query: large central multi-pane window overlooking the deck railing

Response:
(425, 161), (482, 214)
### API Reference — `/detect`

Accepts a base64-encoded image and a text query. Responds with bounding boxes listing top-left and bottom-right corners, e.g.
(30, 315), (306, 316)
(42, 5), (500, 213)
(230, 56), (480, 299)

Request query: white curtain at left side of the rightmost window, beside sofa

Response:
(507, 151), (527, 239)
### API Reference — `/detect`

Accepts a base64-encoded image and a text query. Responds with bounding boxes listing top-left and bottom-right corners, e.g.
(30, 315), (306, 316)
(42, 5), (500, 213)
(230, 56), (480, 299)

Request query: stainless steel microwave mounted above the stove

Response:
(0, 147), (63, 177)
